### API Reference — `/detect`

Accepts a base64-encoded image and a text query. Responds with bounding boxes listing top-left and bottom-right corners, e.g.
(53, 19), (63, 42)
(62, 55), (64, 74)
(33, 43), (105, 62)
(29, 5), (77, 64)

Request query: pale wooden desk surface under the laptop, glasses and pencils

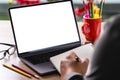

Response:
(0, 21), (82, 80)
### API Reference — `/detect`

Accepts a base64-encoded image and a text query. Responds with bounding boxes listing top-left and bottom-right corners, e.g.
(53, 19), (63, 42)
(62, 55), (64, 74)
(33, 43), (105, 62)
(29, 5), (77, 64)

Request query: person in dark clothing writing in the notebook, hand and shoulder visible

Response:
(61, 14), (120, 80)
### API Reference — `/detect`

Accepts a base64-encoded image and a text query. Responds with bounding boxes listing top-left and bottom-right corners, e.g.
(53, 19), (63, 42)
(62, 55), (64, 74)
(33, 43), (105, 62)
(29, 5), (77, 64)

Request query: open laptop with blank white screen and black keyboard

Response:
(8, 0), (81, 75)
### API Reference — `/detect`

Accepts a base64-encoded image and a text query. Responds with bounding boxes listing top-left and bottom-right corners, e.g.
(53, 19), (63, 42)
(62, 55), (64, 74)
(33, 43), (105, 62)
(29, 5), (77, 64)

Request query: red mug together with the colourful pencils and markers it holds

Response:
(81, 0), (104, 44)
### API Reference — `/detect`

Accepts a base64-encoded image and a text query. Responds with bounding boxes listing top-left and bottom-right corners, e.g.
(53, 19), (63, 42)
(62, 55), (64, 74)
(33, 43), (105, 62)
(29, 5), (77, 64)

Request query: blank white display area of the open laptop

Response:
(10, 1), (79, 53)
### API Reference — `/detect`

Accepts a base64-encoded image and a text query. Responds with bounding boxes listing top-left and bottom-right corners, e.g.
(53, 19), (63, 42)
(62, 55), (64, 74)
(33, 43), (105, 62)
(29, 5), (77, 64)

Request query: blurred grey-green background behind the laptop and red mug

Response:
(0, 0), (120, 21)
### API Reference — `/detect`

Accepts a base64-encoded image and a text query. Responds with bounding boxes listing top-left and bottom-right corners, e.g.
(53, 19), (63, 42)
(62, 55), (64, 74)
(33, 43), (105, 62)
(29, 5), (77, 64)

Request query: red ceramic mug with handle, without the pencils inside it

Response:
(82, 17), (102, 43)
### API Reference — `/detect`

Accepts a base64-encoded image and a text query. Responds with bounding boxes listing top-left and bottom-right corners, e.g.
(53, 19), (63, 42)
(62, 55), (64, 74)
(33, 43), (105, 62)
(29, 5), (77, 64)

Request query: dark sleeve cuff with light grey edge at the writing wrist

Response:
(64, 72), (83, 80)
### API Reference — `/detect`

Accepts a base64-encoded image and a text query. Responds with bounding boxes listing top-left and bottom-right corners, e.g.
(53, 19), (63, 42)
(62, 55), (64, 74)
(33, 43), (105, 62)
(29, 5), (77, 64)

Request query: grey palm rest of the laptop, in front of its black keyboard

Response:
(21, 59), (58, 76)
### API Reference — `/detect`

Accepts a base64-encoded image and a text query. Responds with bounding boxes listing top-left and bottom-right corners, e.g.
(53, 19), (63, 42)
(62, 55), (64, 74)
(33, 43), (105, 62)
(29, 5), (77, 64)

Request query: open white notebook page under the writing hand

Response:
(50, 43), (93, 73)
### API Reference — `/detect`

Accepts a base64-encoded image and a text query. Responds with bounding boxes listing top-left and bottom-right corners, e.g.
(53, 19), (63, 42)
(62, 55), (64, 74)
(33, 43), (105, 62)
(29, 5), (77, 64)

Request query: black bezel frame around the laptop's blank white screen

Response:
(8, 0), (81, 57)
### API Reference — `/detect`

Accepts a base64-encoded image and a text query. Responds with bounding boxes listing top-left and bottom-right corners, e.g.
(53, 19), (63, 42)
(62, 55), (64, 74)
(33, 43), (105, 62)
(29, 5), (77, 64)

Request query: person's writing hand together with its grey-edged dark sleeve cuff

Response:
(60, 52), (89, 80)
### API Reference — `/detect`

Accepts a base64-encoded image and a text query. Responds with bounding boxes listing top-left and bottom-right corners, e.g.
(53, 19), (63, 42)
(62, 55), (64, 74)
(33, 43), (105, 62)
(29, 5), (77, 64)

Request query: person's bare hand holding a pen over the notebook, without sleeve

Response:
(60, 52), (89, 80)
